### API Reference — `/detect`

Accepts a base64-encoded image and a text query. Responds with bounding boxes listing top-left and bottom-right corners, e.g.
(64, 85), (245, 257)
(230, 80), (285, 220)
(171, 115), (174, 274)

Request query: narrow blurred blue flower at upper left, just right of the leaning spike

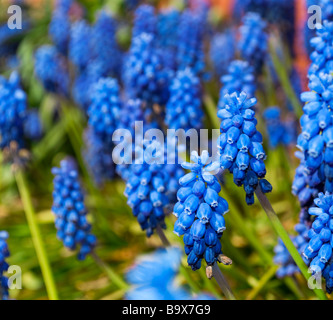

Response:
(69, 20), (92, 70)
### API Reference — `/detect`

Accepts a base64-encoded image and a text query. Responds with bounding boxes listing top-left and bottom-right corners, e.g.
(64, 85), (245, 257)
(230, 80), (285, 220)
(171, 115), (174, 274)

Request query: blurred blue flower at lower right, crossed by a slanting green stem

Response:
(274, 223), (309, 278)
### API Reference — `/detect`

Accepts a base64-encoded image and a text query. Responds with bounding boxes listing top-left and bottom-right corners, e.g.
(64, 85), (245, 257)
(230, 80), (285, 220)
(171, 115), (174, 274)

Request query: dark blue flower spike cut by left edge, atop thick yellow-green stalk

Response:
(0, 72), (27, 150)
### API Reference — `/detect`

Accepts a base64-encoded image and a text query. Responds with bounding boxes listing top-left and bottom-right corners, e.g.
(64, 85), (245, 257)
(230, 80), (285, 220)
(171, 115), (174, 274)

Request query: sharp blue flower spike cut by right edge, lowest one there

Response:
(303, 192), (333, 273)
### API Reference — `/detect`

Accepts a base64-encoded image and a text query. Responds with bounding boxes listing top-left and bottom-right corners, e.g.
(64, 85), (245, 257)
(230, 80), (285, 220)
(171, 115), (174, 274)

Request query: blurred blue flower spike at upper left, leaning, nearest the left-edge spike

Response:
(35, 45), (69, 95)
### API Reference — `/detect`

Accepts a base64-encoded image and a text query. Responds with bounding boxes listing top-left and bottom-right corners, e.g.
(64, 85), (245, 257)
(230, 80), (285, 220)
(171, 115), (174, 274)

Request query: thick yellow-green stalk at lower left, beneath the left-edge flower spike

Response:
(15, 171), (58, 300)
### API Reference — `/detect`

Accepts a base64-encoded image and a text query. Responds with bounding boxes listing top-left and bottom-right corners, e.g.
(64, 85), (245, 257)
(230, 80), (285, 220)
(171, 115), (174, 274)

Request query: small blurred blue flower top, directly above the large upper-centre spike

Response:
(132, 4), (157, 38)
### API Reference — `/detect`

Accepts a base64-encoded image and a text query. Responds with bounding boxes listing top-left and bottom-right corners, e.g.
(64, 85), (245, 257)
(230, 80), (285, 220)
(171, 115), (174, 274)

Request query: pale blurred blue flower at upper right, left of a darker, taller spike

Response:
(209, 29), (236, 77)
